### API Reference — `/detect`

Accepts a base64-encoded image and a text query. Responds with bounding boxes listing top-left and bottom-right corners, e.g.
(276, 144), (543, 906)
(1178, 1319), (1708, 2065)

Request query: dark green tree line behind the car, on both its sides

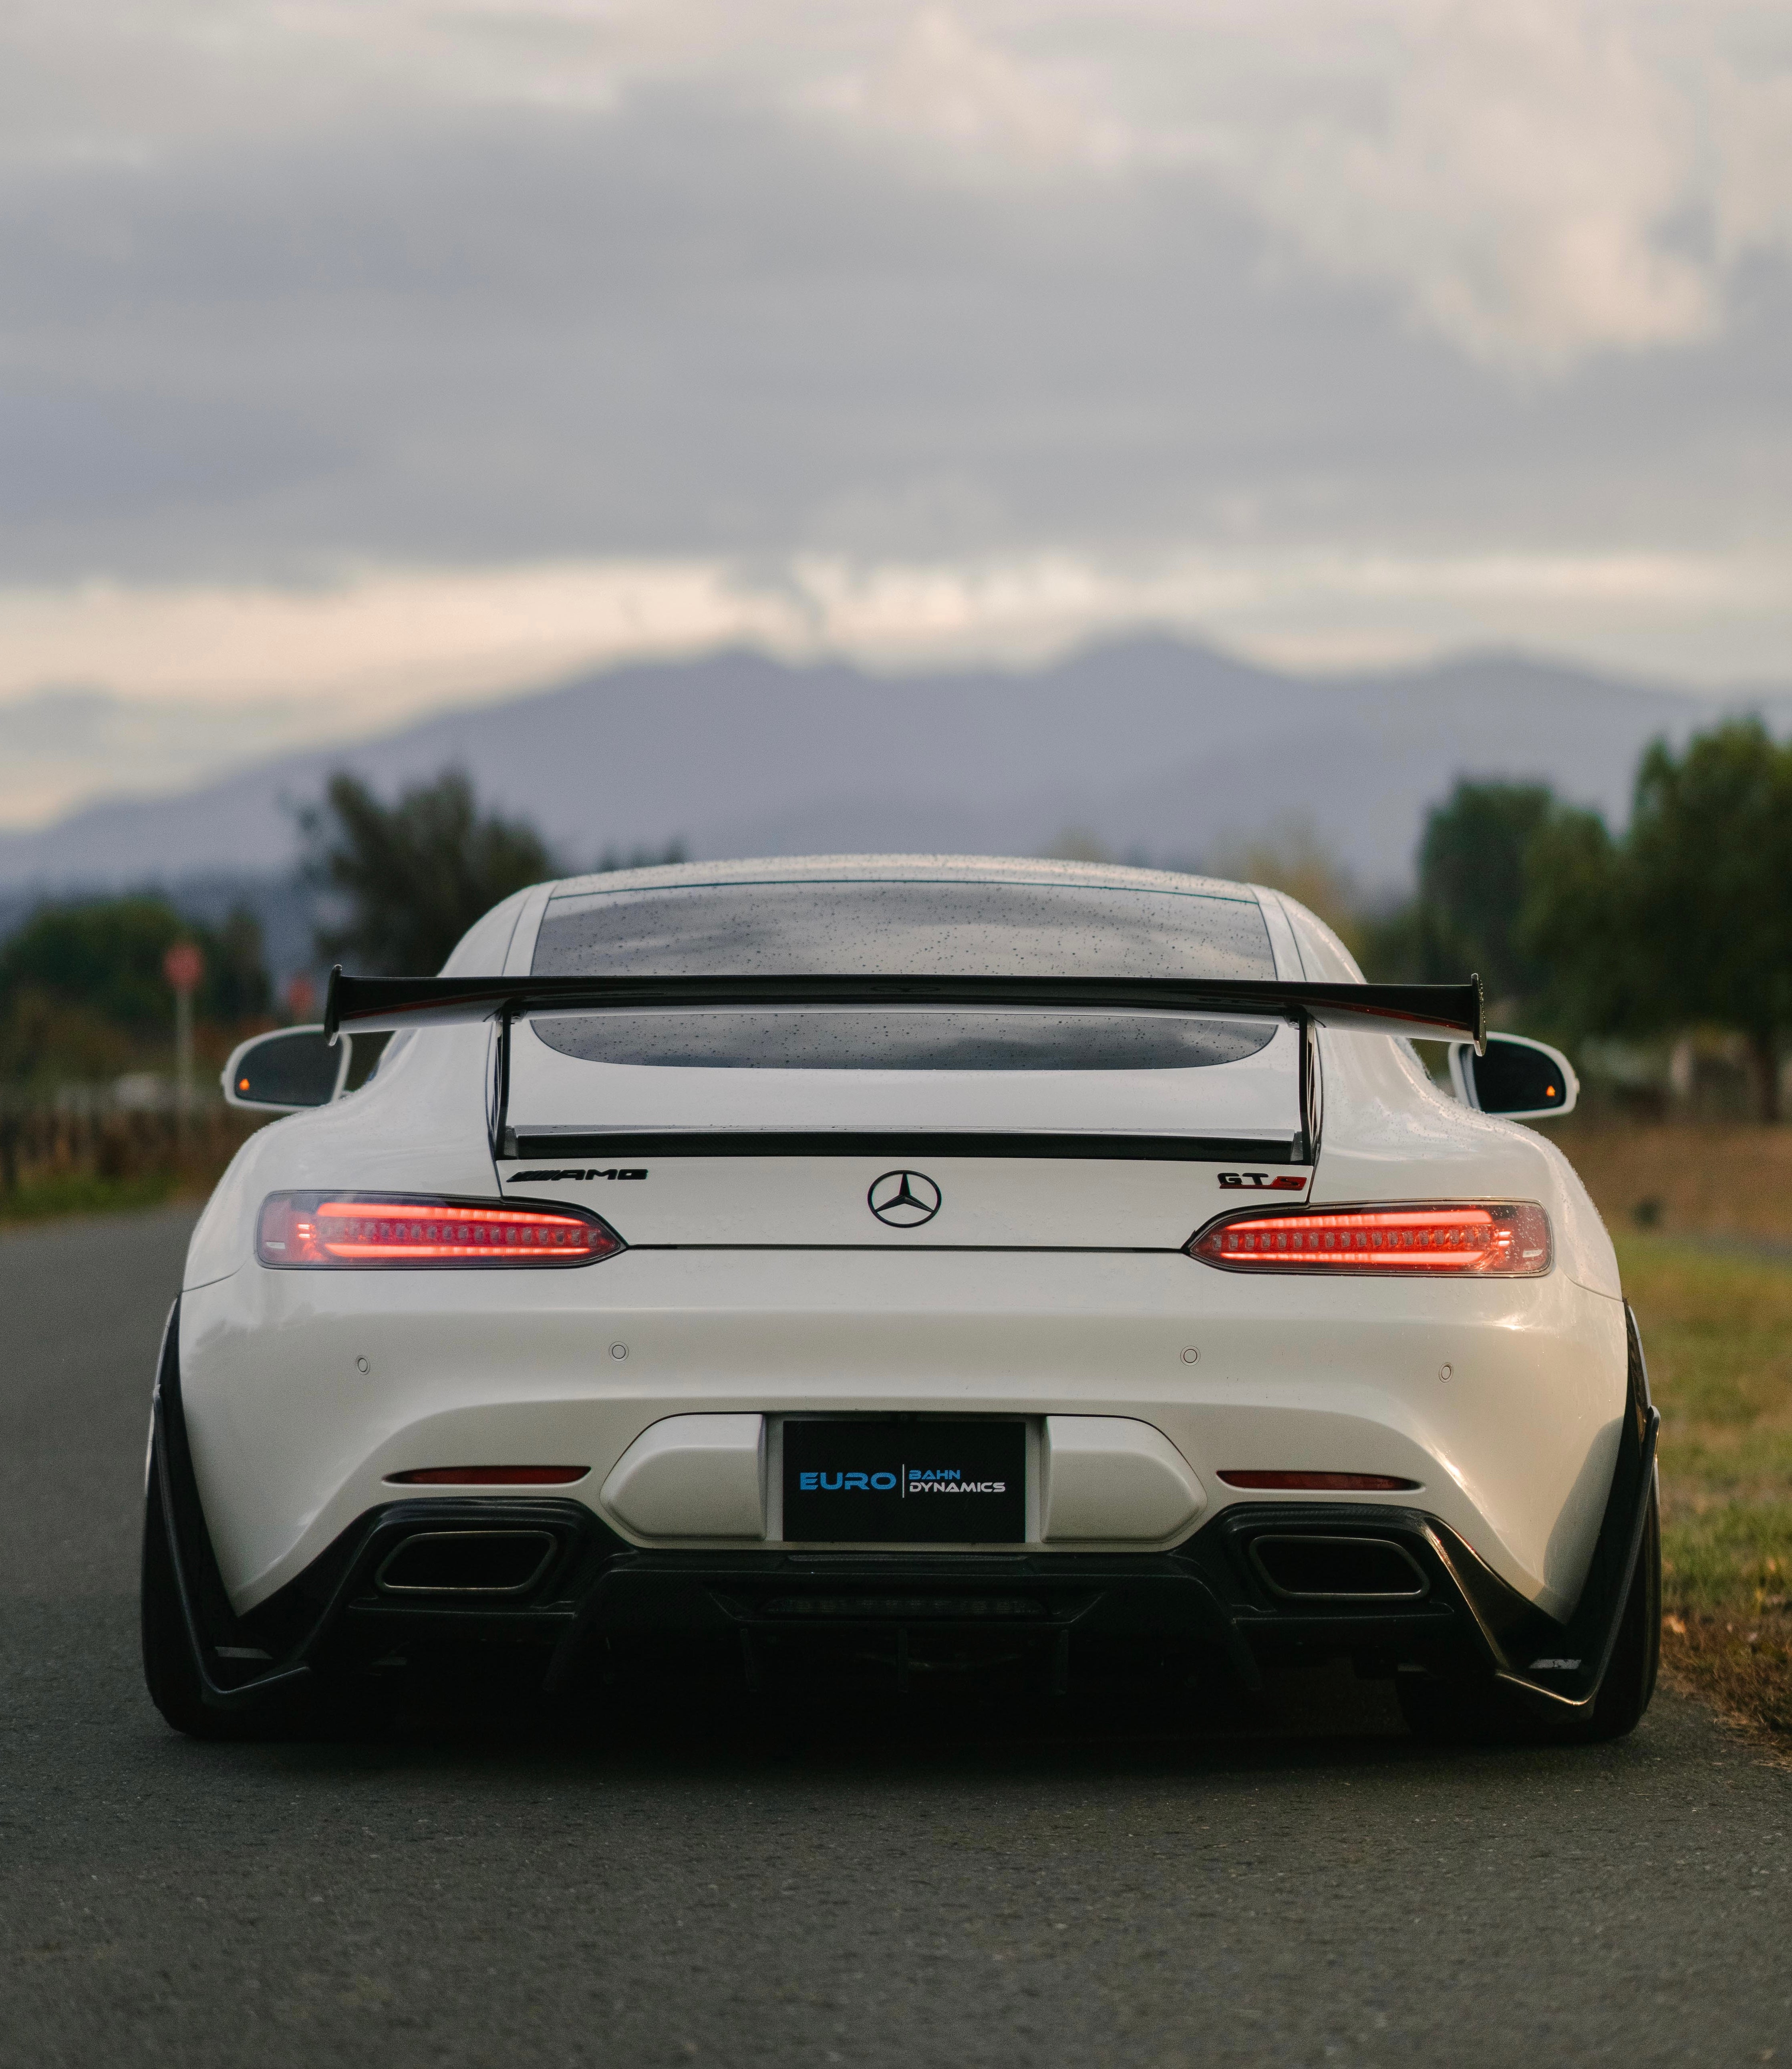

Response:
(0, 720), (1792, 1119)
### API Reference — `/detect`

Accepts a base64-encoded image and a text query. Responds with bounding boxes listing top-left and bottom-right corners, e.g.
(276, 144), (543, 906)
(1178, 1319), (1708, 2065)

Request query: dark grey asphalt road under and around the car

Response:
(0, 1215), (1792, 2069)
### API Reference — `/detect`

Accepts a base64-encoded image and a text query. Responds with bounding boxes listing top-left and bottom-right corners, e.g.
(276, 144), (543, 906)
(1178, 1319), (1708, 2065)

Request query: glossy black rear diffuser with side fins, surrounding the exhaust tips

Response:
(153, 1318), (1657, 1709)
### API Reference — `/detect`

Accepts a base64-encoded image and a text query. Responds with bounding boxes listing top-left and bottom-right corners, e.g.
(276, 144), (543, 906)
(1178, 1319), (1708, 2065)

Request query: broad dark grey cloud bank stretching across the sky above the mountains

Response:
(0, 89), (1792, 581)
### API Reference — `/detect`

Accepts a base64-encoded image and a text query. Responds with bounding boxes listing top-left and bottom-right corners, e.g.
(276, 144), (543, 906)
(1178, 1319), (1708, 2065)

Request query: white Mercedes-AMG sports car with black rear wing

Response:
(143, 856), (1659, 1738)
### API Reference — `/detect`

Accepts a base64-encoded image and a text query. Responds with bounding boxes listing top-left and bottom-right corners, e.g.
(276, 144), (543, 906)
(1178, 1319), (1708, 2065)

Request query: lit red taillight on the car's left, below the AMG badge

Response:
(254, 1192), (623, 1270)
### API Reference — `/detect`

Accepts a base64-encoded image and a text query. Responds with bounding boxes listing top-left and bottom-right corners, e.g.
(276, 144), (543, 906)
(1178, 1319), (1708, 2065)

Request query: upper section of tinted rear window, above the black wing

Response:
(534, 879), (1275, 977)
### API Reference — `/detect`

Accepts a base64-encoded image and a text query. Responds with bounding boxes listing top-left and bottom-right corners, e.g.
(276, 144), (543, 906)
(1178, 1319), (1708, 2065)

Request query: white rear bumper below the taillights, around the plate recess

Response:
(180, 1252), (1625, 1616)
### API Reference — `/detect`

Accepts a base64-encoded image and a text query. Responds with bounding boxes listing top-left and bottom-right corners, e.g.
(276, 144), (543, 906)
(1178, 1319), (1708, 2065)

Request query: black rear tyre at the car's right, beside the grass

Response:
(1395, 1490), (1662, 1746)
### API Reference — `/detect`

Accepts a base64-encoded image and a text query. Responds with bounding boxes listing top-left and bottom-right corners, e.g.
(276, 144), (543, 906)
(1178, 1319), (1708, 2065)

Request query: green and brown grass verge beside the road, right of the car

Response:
(1618, 1235), (1792, 1748)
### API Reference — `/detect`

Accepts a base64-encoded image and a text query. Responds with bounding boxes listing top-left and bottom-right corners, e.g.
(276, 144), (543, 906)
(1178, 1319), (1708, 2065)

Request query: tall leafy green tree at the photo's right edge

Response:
(1525, 718), (1792, 1119)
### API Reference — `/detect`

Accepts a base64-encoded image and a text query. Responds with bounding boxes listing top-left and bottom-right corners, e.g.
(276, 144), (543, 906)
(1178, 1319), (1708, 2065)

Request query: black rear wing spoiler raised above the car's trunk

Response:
(323, 964), (1488, 1051)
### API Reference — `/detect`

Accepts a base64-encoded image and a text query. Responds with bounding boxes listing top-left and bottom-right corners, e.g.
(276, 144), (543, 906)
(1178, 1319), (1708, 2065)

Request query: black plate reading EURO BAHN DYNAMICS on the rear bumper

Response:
(784, 1415), (1026, 1545)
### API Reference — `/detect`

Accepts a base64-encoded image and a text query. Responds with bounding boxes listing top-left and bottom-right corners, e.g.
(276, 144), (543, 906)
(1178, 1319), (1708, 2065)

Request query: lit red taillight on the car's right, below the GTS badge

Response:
(1188, 1200), (1550, 1279)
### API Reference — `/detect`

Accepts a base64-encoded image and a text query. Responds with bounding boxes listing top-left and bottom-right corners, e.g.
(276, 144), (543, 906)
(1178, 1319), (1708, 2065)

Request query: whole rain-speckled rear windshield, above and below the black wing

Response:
(524, 879), (1275, 1070)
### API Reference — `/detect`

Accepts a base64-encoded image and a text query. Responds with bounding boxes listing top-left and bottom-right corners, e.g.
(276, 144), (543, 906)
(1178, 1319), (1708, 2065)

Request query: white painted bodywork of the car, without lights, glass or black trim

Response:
(180, 858), (1625, 1616)
